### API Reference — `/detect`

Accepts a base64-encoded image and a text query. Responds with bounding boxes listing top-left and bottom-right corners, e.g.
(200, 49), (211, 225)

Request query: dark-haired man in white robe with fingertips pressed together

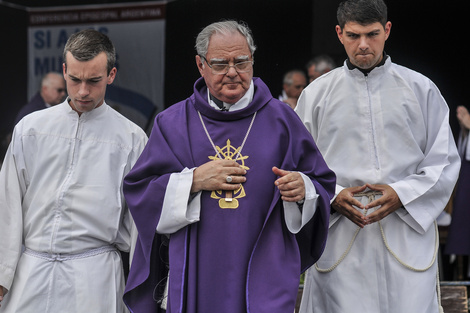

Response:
(296, 0), (460, 313)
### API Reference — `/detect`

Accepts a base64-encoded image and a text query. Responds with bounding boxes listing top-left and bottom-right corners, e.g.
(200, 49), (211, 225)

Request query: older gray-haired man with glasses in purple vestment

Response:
(124, 21), (335, 313)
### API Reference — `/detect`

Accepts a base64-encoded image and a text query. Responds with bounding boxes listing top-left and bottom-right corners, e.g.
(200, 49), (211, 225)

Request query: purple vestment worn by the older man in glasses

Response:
(124, 78), (335, 313)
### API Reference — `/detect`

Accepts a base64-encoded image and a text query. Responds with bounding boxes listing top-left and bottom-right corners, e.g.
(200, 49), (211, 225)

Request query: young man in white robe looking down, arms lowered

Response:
(0, 30), (147, 313)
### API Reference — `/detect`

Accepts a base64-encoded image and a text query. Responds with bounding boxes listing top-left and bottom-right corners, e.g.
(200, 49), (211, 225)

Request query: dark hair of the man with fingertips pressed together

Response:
(336, 0), (387, 29)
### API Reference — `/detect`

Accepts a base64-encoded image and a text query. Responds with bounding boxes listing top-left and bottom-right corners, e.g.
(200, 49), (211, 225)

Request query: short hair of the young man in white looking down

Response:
(63, 29), (116, 75)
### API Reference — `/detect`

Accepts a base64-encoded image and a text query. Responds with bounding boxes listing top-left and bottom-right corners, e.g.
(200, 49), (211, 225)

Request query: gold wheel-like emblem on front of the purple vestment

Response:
(209, 139), (250, 209)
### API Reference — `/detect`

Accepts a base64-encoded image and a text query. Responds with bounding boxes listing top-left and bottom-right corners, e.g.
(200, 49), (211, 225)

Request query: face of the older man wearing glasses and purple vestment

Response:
(196, 32), (253, 104)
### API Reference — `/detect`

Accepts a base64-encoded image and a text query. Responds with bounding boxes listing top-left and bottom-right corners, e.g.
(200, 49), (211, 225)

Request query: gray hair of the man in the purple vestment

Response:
(195, 20), (256, 58)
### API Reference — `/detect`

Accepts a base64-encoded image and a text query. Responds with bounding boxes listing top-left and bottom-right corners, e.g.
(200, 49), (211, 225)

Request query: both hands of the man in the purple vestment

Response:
(191, 160), (305, 202)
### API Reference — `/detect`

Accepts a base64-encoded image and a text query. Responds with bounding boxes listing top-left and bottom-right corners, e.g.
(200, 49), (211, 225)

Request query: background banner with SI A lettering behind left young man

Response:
(27, 1), (166, 131)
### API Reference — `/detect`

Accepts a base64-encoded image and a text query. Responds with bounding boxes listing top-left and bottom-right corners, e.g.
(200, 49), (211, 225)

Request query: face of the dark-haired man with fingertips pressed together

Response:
(336, 22), (392, 70)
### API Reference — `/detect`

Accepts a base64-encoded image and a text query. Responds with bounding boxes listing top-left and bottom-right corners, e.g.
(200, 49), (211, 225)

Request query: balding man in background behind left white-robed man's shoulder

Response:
(14, 72), (67, 125)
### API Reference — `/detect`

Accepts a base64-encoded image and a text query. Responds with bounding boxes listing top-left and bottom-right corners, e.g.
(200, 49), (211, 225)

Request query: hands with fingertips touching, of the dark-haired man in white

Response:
(331, 184), (402, 228)
